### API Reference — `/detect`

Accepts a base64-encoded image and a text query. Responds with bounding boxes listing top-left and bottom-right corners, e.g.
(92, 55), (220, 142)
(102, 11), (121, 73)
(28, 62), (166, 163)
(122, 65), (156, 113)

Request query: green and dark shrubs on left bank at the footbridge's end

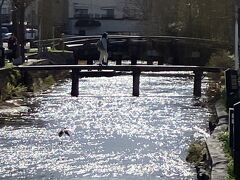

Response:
(0, 63), (67, 103)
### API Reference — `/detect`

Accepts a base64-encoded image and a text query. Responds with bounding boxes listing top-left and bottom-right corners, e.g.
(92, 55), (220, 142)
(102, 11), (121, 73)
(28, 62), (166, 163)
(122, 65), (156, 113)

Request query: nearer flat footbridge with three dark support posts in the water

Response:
(18, 65), (224, 97)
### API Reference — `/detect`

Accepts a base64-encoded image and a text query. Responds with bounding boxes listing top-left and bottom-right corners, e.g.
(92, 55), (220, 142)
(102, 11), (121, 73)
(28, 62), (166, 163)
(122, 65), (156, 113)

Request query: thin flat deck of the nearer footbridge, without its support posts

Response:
(18, 65), (224, 73)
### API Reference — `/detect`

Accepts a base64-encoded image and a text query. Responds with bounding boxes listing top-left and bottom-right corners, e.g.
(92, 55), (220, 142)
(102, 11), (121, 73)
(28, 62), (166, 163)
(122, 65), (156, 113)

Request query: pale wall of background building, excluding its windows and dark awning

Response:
(68, 0), (143, 35)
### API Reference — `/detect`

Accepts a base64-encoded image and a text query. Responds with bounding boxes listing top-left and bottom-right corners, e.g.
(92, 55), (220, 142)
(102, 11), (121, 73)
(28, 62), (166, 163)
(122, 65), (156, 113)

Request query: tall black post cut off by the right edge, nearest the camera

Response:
(233, 102), (240, 179)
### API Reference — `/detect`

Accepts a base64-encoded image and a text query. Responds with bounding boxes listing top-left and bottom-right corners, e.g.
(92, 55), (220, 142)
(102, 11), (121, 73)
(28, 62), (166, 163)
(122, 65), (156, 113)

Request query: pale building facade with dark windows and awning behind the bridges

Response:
(67, 0), (143, 35)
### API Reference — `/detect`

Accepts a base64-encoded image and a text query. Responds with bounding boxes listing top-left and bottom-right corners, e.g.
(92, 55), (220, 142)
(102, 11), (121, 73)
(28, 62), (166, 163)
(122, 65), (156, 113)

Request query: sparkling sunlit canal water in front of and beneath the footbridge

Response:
(0, 73), (212, 180)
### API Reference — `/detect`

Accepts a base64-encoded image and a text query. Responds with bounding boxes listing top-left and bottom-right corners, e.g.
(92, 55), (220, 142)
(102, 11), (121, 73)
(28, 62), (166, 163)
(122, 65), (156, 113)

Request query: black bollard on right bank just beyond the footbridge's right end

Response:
(225, 69), (239, 108)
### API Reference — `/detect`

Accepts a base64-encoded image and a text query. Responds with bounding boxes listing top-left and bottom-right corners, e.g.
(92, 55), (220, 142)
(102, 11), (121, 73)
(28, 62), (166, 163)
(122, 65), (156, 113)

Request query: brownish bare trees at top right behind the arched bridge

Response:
(128, 0), (234, 41)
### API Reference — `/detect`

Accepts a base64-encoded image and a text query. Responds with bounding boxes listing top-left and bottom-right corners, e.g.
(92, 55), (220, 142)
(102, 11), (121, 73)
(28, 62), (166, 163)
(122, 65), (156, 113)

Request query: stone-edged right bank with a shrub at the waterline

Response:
(187, 99), (229, 180)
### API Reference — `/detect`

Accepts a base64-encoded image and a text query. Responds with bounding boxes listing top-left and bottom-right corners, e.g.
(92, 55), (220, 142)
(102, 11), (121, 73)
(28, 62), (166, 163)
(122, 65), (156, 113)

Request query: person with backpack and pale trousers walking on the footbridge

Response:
(97, 32), (108, 66)
